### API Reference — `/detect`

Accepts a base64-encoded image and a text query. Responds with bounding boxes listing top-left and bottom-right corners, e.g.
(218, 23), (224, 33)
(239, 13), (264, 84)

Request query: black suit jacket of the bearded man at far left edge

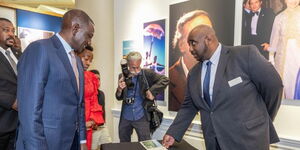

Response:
(0, 49), (21, 136)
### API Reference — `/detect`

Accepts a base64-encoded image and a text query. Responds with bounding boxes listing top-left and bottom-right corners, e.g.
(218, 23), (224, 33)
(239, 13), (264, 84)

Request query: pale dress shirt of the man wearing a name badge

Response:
(201, 43), (222, 101)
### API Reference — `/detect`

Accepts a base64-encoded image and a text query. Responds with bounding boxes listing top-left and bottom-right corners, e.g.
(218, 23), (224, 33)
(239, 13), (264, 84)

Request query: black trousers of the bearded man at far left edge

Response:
(0, 131), (16, 150)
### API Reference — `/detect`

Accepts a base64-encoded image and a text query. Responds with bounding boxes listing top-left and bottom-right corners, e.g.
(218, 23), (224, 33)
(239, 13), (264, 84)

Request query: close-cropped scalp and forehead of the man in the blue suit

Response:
(61, 9), (94, 31)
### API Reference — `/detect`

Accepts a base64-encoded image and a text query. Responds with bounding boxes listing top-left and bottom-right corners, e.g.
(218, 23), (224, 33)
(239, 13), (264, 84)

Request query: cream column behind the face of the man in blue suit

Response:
(76, 0), (115, 139)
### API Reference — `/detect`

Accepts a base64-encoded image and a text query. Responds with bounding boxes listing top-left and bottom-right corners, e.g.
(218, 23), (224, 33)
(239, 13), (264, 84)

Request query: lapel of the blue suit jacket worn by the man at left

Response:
(51, 36), (79, 96)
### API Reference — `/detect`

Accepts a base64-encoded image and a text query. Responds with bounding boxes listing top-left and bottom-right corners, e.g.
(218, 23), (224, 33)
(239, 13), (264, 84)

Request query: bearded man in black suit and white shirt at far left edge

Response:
(0, 18), (19, 150)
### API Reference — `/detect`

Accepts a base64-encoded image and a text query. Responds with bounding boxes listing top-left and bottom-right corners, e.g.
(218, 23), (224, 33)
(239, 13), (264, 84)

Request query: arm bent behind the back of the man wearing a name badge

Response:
(247, 45), (283, 120)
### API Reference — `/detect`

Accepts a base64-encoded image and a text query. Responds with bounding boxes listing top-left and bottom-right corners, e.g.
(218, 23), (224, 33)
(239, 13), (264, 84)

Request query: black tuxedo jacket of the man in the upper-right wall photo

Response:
(243, 8), (275, 59)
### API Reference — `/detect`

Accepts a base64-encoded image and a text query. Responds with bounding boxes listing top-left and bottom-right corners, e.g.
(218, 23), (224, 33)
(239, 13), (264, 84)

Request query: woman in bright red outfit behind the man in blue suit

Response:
(78, 46), (104, 150)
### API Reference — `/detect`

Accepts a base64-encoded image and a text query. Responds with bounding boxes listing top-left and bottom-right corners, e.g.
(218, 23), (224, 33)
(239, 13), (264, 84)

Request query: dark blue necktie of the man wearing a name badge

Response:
(203, 61), (211, 107)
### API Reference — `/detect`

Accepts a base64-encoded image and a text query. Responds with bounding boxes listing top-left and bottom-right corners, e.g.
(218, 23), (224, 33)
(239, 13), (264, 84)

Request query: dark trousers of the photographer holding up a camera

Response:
(119, 116), (151, 142)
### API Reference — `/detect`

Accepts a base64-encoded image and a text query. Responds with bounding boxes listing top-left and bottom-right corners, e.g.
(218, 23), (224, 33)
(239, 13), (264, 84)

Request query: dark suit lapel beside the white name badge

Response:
(212, 46), (229, 109)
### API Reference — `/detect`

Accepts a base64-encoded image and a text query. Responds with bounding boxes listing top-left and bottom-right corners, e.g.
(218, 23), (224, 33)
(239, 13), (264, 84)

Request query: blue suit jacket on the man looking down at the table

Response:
(17, 36), (86, 150)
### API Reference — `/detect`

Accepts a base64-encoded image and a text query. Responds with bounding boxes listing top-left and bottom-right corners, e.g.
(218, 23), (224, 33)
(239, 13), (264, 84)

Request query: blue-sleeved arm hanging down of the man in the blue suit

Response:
(17, 43), (49, 150)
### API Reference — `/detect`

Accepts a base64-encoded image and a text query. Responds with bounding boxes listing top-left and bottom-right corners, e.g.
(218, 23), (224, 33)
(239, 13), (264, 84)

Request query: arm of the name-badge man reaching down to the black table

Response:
(163, 74), (198, 147)
